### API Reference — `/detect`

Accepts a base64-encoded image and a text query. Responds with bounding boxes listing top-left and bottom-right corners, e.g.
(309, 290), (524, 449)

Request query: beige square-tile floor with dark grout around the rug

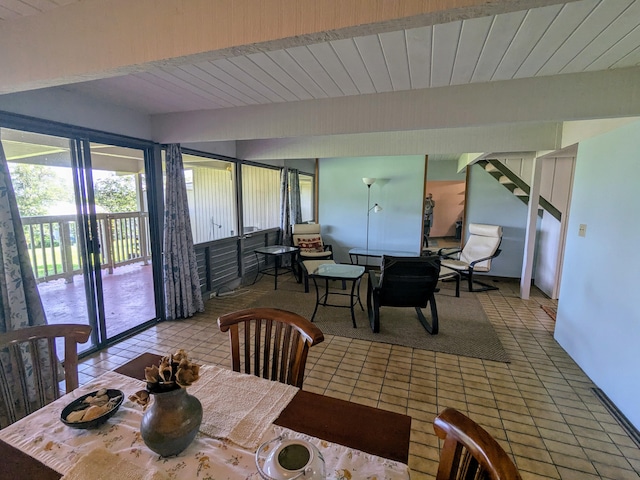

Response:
(80, 280), (640, 480)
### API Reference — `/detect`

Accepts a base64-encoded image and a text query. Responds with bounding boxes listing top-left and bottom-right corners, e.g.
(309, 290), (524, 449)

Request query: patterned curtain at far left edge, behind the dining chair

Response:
(0, 135), (55, 424)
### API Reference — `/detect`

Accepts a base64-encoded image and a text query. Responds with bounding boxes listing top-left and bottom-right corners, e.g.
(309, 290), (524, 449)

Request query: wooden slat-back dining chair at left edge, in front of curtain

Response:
(0, 324), (91, 428)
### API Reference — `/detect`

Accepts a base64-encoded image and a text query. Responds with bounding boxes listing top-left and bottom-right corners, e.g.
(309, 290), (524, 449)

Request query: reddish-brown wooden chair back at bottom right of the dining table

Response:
(433, 408), (522, 480)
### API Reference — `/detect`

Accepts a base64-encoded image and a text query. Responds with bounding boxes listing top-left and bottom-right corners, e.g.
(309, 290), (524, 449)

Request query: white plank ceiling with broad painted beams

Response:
(0, 0), (640, 158)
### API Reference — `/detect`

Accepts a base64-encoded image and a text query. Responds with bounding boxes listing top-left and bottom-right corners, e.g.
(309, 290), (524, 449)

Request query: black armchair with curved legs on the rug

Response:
(367, 255), (440, 335)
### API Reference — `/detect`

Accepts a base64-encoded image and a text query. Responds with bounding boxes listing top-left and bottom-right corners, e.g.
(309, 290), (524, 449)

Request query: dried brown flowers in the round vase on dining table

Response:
(129, 349), (200, 408)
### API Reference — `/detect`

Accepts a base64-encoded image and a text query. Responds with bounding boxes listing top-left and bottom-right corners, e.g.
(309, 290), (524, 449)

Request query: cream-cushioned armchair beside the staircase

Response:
(438, 223), (502, 292)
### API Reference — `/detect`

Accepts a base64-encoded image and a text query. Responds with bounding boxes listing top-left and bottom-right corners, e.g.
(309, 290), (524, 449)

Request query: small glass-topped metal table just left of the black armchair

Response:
(308, 263), (365, 328)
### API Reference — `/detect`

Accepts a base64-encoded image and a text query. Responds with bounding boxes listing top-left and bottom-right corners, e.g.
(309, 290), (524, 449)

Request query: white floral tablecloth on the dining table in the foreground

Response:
(0, 367), (409, 480)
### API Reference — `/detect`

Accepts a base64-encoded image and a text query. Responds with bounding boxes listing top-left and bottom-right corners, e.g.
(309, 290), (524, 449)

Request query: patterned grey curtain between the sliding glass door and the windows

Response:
(163, 144), (204, 320)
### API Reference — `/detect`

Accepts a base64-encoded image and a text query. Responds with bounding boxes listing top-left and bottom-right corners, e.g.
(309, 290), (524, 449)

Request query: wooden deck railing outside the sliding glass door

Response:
(22, 212), (151, 283)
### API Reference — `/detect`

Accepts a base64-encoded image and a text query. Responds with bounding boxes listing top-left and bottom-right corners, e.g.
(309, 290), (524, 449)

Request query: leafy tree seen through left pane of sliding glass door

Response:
(10, 163), (70, 217)
